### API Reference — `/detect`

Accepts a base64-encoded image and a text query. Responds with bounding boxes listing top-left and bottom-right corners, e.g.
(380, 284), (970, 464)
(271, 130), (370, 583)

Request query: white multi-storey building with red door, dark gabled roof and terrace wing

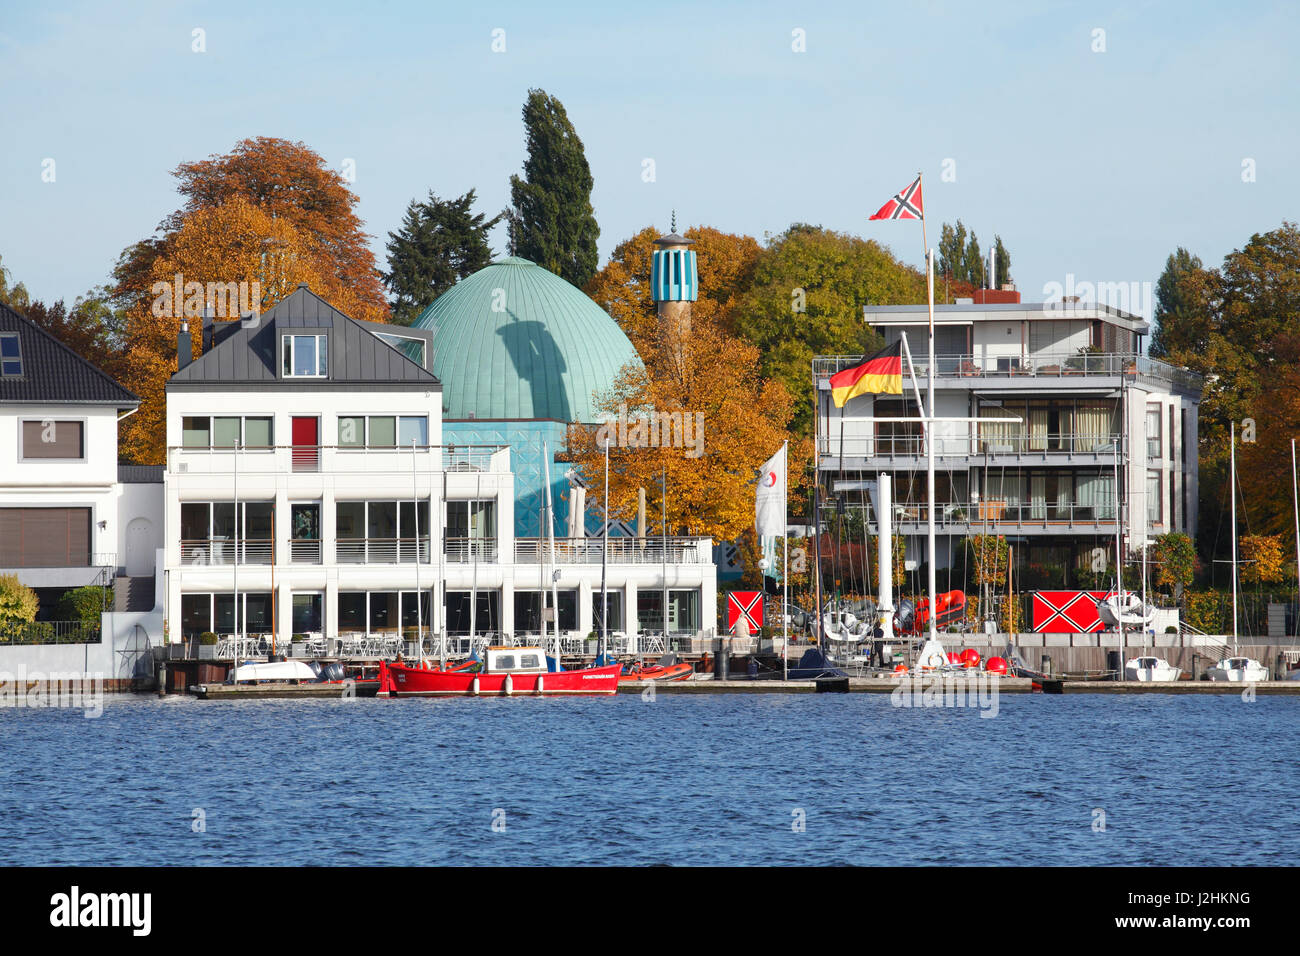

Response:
(165, 286), (718, 653)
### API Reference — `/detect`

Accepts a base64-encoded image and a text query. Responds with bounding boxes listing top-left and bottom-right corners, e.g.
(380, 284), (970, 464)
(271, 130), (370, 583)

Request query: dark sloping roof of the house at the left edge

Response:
(0, 303), (140, 408)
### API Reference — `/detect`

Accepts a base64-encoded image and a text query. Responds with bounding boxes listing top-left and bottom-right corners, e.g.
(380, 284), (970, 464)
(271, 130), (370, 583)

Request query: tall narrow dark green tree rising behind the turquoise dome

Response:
(507, 90), (601, 289)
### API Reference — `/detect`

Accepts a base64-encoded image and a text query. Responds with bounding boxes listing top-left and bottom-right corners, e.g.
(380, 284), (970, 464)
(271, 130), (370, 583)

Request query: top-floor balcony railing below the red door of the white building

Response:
(168, 445), (510, 475)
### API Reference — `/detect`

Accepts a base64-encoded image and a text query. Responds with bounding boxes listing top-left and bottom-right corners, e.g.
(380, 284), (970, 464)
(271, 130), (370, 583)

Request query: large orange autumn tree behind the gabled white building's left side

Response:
(109, 137), (389, 463)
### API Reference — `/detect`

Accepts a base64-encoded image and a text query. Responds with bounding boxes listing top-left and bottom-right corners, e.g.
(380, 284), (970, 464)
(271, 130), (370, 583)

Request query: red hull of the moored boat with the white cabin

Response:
(380, 663), (621, 697)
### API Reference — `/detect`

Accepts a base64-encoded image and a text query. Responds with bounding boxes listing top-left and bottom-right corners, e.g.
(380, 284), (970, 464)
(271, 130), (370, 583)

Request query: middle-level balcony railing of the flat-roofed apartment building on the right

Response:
(820, 434), (1119, 460)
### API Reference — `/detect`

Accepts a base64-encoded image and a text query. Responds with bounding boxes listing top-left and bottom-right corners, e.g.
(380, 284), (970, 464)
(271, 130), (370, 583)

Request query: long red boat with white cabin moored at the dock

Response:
(378, 648), (621, 697)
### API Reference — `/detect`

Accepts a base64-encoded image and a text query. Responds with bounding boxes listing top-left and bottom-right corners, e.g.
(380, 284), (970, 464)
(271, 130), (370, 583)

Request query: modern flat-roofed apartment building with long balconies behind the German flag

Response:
(814, 293), (1201, 587)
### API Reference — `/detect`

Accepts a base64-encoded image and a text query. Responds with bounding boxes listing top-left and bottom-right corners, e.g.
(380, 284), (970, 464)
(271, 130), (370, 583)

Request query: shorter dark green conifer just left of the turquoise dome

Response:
(384, 190), (503, 325)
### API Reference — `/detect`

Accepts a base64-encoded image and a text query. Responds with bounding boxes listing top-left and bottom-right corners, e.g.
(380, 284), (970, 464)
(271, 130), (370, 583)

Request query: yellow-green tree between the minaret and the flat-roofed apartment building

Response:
(735, 224), (926, 437)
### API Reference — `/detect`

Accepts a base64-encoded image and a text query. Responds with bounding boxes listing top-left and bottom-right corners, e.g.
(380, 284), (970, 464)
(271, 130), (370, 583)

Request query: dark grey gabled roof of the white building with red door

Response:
(166, 284), (441, 389)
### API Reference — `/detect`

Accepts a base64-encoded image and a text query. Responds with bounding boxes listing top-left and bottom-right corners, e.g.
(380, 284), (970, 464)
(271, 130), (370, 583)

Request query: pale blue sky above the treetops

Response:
(0, 0), (1300, 316)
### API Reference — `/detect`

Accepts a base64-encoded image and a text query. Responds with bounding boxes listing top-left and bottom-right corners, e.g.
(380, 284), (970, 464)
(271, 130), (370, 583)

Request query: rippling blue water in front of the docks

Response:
(0, 693), (1300, 865)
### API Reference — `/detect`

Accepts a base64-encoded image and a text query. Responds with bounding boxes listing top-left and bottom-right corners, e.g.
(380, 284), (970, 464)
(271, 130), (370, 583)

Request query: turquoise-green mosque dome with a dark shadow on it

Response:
(413, 256), (640, 421)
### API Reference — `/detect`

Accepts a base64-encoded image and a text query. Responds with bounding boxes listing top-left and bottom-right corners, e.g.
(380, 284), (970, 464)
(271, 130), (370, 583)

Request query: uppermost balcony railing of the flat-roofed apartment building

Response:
(813, 350), (1203, 394)
